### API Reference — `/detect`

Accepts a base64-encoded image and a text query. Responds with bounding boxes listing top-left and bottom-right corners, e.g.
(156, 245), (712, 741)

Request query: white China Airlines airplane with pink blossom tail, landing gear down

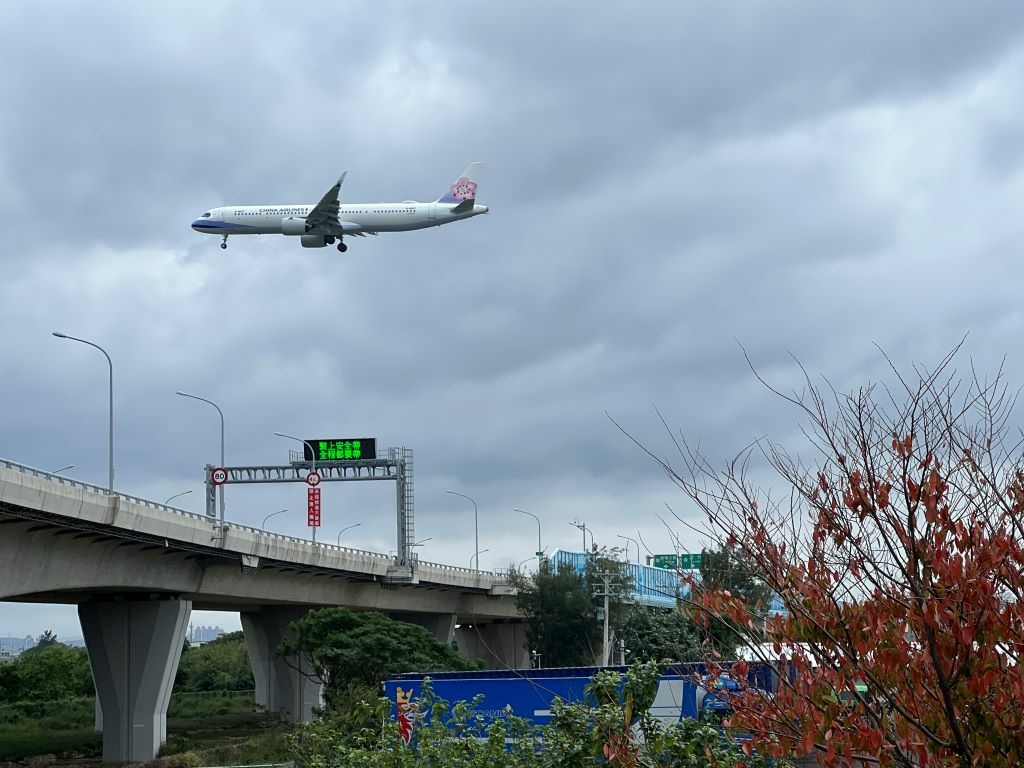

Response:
(191, 163), (488, 253)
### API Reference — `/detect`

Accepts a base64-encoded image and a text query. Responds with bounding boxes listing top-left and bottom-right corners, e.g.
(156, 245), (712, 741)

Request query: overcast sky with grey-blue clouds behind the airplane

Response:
(0, 0), (1024, 637)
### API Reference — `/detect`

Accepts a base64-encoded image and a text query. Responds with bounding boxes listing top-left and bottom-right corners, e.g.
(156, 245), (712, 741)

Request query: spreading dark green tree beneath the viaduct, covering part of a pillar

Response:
(278, 608), (479, 710)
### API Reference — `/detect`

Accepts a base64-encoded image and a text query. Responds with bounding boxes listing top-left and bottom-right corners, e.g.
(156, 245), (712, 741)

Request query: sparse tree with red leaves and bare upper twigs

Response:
(658, 346), (1024, 768)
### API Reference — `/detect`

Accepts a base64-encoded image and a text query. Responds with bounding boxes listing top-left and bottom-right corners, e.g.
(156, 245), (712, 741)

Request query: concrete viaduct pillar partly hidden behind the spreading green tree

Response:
(242, 605), (324, 723)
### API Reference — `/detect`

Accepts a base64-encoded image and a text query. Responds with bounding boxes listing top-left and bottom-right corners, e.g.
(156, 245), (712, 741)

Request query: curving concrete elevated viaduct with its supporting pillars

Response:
(0, 459), (529, 762)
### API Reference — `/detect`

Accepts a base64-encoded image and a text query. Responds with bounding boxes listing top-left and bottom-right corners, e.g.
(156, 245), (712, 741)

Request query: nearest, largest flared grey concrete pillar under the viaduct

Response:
(78, 600), (191, 763)
